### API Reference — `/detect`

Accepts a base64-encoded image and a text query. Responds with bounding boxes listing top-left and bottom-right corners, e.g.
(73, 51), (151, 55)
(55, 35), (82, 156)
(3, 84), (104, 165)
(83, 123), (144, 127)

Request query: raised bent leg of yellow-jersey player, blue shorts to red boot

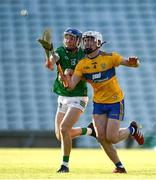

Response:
(106, 101), (144, 144)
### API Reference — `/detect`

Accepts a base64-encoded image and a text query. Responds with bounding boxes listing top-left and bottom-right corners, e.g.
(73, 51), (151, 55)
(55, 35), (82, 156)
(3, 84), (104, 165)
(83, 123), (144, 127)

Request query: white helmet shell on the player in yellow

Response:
(82, 31), (103, 47)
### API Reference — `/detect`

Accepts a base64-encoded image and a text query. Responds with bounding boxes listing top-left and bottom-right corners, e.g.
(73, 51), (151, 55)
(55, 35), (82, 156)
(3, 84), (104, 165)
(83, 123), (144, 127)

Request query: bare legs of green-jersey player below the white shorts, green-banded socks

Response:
(56, 108), (92, 173)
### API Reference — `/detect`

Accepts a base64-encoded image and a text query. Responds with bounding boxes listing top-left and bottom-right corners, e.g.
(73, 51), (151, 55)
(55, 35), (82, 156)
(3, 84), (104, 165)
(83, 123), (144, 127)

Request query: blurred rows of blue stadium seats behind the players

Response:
(0, 0), (156, 146)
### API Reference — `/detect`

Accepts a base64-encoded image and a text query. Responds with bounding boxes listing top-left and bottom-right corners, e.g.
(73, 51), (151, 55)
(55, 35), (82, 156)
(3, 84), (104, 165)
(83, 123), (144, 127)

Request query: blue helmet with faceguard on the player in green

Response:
(63, 28), (82, 51)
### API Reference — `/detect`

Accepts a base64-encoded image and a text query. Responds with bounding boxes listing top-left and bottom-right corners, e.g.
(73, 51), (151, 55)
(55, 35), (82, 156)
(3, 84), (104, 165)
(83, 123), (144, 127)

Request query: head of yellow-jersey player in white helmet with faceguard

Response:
(82, 31), (103, 54)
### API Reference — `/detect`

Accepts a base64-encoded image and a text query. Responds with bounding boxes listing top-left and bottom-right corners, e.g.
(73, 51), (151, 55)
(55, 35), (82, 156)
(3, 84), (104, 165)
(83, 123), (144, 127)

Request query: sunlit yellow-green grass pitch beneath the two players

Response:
(0, 149), (156, 180)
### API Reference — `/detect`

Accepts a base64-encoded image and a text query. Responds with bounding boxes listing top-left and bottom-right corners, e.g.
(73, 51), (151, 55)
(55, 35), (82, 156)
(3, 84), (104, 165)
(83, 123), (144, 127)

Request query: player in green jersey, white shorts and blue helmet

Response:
(46, 28), (95, 173)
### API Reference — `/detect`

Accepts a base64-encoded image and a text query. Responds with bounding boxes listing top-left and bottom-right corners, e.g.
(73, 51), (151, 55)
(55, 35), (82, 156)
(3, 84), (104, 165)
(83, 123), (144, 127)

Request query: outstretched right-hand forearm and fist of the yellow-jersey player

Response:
(120, 56), (140, 67)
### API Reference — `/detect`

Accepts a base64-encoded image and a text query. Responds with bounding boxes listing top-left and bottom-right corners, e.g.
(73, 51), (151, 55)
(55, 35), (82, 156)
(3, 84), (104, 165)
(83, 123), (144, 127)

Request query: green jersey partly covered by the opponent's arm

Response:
(53, 46), (87, 97)
